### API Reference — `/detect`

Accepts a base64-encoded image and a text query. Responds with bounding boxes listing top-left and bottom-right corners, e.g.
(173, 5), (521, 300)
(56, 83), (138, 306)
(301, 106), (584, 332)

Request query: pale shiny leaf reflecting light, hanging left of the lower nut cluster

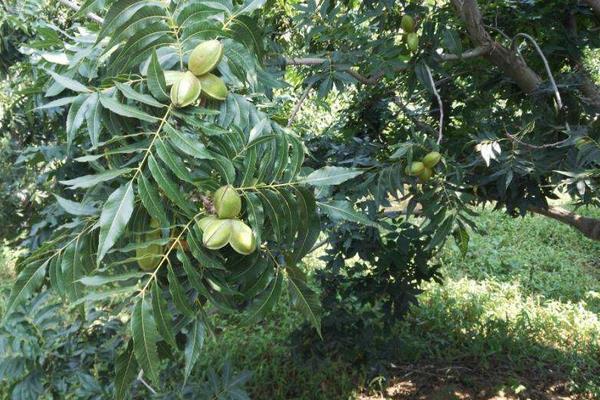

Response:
(96, 181), (134, 264)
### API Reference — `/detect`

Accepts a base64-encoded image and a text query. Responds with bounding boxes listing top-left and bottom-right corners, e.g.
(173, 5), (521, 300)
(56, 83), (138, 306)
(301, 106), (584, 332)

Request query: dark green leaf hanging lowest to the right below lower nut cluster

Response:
(286, 266), (322, 338)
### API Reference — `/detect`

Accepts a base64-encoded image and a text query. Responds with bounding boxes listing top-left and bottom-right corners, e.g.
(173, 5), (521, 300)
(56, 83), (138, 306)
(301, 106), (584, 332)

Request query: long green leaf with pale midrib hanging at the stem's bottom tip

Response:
(131, 295), (160, 386)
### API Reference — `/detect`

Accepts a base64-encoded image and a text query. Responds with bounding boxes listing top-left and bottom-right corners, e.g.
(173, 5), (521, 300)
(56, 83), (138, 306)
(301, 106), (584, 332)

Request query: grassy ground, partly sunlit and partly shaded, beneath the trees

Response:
(198, 210), (600, 400)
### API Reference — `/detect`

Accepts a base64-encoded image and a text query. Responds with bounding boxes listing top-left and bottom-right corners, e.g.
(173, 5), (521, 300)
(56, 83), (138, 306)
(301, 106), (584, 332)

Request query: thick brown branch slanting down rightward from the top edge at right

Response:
(452, 0), (542, 94)
